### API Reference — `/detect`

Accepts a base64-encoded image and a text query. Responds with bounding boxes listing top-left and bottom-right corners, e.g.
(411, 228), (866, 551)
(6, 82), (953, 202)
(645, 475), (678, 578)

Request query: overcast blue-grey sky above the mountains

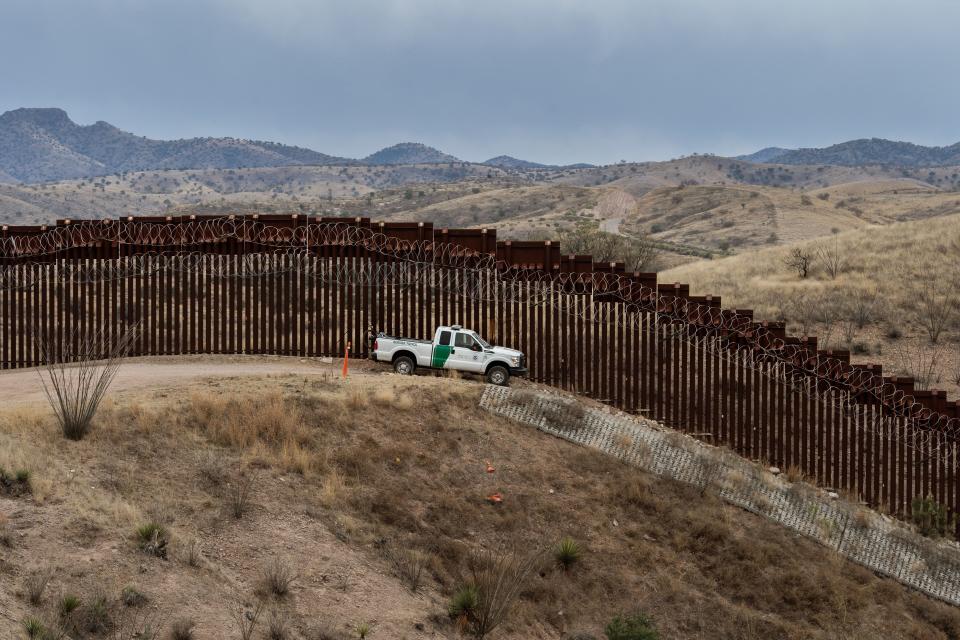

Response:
(0, 0), (960, 163)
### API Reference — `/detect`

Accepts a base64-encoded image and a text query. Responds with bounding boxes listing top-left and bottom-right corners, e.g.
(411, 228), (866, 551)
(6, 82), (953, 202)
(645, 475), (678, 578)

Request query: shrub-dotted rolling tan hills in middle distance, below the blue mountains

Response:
(0, 157), (960, 276)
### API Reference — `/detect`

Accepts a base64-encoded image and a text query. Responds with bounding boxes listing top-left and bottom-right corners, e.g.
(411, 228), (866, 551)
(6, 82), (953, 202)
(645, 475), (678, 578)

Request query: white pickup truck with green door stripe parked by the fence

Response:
(371, 324), (527, 385)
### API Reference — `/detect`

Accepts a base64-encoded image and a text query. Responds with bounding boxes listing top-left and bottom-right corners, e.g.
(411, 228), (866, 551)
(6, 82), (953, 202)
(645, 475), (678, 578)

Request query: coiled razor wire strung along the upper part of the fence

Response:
(0, 217), (960, 442)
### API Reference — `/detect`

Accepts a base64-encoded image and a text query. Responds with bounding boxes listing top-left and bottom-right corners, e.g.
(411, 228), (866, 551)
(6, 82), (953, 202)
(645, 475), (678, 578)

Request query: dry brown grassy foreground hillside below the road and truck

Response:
(0, 367), (960, 640)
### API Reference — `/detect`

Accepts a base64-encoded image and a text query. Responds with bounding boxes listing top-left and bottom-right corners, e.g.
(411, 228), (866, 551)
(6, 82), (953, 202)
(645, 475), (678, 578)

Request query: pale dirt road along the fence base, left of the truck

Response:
(0, 355), (389, 405)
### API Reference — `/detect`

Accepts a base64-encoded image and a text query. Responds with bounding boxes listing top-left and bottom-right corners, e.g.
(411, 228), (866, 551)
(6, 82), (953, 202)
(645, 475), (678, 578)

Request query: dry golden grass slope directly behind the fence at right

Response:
(661, 215), (960, 397)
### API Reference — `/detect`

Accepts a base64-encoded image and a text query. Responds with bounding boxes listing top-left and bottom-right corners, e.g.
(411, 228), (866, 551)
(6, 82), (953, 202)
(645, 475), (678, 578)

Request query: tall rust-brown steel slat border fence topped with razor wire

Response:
(0, 215), (960, 532)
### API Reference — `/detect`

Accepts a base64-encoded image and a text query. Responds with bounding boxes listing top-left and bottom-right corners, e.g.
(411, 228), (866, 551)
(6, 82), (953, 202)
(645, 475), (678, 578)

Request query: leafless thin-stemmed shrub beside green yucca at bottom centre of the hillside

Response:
(450, 551), (543, 638)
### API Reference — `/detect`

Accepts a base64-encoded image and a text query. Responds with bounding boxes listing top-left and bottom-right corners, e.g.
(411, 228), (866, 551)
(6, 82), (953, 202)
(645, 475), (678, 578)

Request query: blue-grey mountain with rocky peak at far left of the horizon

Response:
(0, 109), (346, 182)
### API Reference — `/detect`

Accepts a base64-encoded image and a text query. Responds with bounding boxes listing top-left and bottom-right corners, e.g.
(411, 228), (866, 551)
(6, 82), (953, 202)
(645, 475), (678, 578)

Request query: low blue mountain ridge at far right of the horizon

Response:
(740, 138), (960, 167)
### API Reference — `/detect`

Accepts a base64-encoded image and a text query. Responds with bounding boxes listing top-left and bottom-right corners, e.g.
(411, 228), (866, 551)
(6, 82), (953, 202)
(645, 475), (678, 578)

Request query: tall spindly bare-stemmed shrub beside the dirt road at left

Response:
(35, 325), (140, 440)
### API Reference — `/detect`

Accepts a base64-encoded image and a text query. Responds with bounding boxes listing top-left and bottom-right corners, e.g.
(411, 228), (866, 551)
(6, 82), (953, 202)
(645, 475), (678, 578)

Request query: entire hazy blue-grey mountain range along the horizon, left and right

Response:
(7, 108), (960, 184)
